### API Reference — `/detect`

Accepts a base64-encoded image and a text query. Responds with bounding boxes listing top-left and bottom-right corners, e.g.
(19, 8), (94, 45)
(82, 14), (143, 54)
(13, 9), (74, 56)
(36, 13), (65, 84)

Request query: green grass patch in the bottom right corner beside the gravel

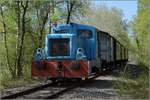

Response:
(114, 64), (149, 99)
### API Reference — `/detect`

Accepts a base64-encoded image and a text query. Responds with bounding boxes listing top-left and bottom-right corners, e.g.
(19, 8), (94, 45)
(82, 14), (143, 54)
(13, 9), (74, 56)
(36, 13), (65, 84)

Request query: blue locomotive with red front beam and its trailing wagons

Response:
(32, 23), (128, 79)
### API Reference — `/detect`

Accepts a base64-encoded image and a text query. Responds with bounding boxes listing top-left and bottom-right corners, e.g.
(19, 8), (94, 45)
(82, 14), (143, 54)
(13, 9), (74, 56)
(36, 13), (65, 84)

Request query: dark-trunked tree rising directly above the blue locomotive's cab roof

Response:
(56, 0), (89, 24)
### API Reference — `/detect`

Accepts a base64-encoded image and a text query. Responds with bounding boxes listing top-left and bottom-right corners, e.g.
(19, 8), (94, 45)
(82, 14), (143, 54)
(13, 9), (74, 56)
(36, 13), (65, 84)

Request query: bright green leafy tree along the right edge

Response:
(133, 0), (150, 66)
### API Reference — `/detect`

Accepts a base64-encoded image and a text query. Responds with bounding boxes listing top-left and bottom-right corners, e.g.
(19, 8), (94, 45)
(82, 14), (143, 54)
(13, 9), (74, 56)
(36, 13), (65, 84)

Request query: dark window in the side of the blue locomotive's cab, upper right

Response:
(77, 29), (92, 39)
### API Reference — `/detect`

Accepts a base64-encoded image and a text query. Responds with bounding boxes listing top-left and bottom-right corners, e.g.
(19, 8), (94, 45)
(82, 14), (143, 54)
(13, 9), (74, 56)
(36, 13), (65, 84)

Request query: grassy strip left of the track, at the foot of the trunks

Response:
(0, 67), (41, 90)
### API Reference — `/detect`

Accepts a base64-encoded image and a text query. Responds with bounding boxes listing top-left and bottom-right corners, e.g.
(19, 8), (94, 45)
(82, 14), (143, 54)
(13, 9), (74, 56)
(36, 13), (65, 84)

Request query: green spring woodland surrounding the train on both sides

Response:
(0, 0), (150, 97)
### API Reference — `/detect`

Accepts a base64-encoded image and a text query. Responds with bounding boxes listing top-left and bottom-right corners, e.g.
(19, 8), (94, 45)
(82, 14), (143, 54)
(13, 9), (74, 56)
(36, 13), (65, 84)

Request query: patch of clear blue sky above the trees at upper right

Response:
(93, 0), (137, 21)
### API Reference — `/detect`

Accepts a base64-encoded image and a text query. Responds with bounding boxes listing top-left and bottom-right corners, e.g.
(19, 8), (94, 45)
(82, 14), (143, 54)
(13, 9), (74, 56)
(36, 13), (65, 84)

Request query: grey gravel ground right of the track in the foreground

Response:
(58, 75), (130, 100)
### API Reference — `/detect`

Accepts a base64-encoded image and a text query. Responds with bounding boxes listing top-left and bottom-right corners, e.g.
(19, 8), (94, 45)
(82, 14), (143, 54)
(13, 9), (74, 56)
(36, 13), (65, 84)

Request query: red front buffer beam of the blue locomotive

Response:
(32, 60), (90, 78)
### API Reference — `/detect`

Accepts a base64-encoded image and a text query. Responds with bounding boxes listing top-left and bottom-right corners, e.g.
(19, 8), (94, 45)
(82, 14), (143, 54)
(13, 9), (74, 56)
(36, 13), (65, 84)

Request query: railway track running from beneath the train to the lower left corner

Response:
(1, 75), (99, 99)
